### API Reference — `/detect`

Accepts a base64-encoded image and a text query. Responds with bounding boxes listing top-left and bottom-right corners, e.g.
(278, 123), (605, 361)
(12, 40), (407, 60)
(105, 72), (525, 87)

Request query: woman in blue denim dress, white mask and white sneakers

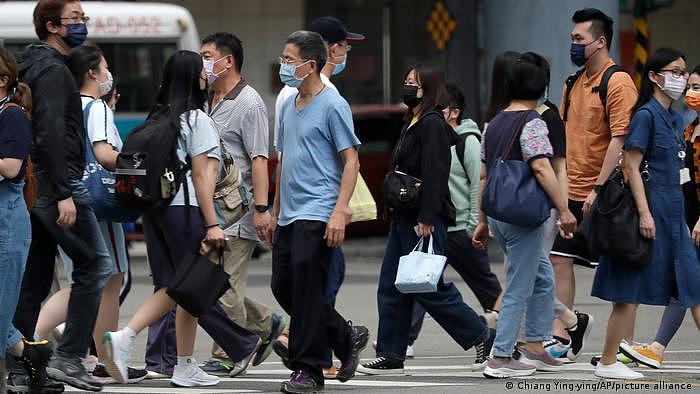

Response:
(592, 48), (700, 379)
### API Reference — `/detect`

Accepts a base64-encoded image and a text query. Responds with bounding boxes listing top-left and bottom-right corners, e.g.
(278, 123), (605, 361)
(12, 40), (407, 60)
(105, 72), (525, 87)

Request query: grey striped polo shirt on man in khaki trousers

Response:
(211, 80), (270, 241)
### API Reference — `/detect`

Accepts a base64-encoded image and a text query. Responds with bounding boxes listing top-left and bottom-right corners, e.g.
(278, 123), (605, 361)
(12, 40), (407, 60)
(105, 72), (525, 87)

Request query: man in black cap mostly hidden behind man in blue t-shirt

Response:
(274, 16), (365, 379)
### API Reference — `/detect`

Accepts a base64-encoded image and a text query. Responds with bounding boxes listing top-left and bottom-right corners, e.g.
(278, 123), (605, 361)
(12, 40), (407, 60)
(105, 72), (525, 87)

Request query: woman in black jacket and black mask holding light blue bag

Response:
(357, 65), (493, 375)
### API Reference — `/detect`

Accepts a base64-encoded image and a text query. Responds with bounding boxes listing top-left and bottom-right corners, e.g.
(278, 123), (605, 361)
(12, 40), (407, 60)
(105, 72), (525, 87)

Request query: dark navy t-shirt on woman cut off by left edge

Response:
(0, 106), (32, 183)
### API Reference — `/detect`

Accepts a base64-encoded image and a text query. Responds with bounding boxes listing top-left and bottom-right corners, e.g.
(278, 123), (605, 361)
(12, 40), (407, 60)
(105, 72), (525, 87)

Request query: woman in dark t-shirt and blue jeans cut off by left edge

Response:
(0, 48), (54, 393)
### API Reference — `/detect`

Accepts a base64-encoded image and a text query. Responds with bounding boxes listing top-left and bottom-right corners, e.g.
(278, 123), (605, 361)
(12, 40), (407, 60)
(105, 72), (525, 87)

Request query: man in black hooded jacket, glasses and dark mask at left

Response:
(9, 0), (111, 392)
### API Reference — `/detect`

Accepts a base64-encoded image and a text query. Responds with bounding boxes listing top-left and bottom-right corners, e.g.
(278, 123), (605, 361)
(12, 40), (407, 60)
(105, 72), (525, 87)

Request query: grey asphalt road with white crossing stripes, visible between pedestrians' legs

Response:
(61, 239), (700, 394)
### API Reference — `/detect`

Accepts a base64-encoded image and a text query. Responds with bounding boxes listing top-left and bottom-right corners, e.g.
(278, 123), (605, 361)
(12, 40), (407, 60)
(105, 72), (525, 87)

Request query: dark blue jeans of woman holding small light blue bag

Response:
(377, 215), (488, 359)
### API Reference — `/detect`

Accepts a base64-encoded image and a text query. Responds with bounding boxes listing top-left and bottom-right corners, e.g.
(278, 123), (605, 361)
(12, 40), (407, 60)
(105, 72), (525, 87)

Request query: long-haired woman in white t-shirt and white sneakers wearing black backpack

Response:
(104, 51), (260, 387)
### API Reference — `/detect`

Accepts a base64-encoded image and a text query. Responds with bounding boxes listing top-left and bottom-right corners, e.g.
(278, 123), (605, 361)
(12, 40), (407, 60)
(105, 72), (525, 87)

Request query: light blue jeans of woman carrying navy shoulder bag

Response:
(489, 218), (554, 357)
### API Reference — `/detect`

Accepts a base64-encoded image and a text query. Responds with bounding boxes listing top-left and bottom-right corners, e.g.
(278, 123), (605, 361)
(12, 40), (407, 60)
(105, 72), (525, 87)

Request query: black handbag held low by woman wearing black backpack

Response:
(166, 249), (229, 317)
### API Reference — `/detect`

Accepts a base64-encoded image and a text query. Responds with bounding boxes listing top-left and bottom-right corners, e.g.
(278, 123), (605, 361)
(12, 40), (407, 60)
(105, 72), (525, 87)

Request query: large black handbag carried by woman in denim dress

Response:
(577, 166), (653, 269)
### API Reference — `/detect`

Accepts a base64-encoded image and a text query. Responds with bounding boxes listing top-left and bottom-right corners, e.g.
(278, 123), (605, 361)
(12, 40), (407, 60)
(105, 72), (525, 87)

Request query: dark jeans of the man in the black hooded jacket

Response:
(14, 180), (112, 358)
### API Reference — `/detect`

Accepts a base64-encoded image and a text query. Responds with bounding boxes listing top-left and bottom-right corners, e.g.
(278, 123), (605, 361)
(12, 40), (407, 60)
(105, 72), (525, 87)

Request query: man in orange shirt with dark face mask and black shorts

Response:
(551, 8), (637, 348)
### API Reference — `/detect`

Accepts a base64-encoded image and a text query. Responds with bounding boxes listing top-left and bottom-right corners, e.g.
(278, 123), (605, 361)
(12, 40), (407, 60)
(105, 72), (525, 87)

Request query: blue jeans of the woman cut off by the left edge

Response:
(0, 180), (32, 354)
